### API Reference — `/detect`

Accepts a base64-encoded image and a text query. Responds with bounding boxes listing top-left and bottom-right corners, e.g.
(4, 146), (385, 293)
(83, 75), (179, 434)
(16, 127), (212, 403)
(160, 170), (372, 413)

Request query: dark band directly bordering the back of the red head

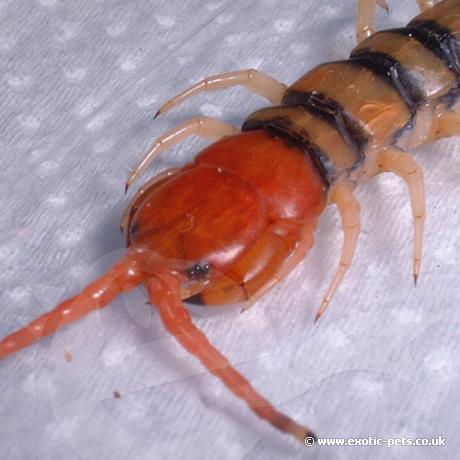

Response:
(241, 118), (337, 186)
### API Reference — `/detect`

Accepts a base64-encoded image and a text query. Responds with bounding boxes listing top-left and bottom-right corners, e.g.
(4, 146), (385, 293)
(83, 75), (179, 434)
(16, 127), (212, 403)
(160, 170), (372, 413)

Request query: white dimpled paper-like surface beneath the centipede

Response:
(0, 0), (460, 460)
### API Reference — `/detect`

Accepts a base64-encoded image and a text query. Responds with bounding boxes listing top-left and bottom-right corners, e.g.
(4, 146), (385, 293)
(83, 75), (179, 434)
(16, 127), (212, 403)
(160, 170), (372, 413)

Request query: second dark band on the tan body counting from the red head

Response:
(282, 91), (370, 161)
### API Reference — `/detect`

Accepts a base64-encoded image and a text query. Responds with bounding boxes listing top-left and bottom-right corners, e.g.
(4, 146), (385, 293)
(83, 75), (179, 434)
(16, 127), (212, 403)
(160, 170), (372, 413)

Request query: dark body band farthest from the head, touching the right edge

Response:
(406, 20), (460, 75)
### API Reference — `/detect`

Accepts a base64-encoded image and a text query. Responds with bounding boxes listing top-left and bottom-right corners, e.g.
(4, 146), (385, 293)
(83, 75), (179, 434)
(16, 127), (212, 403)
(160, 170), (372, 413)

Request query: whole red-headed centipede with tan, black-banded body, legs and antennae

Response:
(0, 0), (460, 443)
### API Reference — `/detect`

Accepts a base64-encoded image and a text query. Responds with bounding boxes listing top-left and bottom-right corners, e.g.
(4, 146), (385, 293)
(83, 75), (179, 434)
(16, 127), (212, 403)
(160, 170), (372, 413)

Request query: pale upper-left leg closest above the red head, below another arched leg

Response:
(126, 116), (239, 190)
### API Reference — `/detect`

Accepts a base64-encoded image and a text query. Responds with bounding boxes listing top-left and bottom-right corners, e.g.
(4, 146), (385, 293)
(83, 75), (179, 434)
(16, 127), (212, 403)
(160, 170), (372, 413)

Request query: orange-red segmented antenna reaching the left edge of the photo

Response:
(0, 256), (145, 359)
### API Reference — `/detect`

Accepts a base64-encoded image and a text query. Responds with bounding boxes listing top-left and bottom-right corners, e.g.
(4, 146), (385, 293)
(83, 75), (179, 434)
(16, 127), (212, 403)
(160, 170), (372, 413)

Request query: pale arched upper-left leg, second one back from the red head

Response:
(155, 69), (286, 118)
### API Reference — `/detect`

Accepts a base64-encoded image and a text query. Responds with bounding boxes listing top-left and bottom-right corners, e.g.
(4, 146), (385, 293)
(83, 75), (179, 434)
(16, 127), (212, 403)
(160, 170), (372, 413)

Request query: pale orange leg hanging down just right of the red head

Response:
(315, 183), (361, 322)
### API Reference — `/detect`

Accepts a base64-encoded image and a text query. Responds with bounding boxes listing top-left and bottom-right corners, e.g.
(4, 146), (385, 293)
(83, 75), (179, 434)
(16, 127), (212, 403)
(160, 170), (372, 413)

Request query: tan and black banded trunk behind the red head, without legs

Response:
(243, 0), (460, 185)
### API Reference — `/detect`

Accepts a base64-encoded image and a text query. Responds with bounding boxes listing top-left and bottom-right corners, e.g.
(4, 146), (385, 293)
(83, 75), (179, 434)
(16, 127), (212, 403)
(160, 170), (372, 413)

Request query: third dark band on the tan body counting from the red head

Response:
(349, 49), (425, 111)
